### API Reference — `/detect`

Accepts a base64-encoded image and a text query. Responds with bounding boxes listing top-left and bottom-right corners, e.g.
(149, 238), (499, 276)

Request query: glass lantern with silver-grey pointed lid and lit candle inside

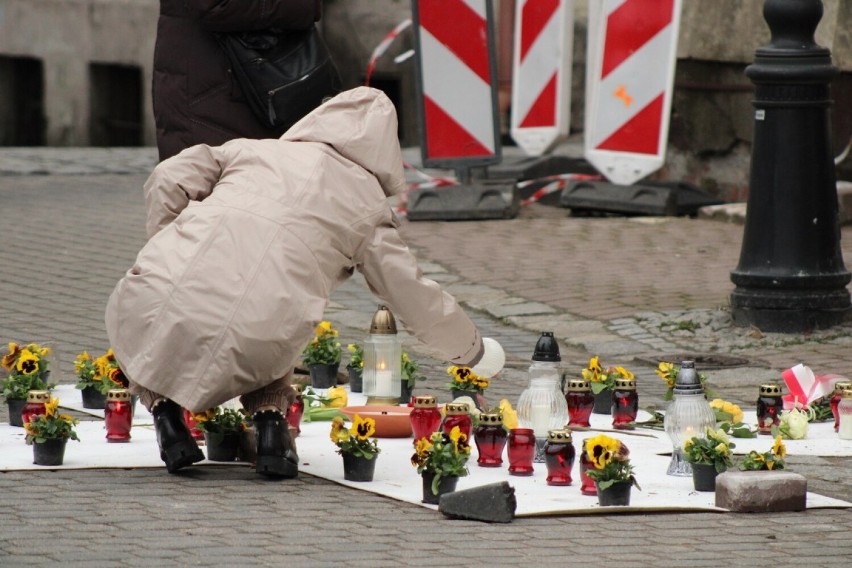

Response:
(663, 361), (716, 477)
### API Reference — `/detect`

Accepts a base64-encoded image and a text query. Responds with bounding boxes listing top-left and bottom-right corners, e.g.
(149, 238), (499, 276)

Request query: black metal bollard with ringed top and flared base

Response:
(731, 0), (850, 333)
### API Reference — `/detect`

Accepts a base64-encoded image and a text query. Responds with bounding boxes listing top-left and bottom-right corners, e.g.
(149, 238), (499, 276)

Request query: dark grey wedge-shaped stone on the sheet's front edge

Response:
(438, 481), (518, 523)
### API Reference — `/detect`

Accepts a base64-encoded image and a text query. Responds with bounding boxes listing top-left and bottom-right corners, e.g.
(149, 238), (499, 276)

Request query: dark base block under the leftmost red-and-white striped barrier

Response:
(408, 180), (520, 221)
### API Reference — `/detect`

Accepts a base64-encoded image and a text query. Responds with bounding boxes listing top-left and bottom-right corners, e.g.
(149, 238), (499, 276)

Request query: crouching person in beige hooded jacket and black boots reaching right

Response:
(106, 87), (504, 477)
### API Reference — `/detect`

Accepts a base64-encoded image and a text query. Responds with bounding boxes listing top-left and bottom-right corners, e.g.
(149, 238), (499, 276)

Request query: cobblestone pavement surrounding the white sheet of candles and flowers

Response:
(0, 148), (852, 567)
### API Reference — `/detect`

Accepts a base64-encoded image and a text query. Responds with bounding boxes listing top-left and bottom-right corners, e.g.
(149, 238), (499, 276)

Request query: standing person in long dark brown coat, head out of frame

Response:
(152, 0), (322, 160)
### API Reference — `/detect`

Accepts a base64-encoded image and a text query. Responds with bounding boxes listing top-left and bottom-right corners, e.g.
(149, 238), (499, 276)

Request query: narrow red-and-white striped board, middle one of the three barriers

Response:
(510, 0), (574, 156)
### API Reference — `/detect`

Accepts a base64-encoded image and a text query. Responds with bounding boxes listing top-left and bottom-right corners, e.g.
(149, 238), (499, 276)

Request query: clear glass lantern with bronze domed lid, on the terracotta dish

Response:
(363, 306), (402, 405)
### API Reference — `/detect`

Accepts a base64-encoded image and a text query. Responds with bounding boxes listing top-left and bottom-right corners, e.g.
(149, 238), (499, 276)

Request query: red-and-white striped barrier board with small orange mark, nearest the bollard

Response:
(585, 0), (681, 185)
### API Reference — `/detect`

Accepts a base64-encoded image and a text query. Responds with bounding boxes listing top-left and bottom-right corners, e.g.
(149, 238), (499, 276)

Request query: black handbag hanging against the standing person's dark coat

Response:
(216, 26), (342, 128)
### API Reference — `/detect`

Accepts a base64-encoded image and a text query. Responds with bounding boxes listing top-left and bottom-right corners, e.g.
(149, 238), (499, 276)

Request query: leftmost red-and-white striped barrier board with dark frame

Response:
(413, 0), (500, 168)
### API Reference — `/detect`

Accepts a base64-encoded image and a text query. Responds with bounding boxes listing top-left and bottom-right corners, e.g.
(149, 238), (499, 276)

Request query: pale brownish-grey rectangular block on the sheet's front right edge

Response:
(716, 470), (808, 513)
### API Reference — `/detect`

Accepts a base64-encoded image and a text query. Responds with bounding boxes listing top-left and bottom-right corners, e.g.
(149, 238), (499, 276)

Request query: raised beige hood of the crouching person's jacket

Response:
(281, 87), (406, 196)
